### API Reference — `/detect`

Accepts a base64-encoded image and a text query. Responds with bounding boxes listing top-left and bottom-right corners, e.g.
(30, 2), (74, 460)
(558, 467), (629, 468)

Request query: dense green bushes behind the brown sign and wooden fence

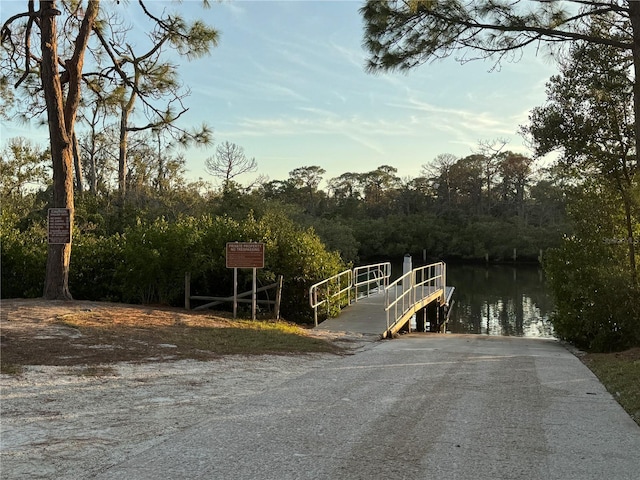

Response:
(2, 212), (346, 322)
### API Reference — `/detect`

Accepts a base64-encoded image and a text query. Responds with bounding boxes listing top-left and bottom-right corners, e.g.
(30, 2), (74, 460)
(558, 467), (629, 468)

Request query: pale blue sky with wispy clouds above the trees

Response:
(0, 0), (557, 188)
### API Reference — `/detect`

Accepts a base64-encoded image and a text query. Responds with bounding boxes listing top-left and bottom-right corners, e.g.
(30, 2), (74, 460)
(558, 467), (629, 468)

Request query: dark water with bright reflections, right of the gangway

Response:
(447, 264), (553, 338)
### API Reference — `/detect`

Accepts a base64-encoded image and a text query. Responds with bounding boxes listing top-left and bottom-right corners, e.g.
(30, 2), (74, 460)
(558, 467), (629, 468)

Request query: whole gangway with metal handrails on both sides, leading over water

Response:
(309, 262), (454, 338)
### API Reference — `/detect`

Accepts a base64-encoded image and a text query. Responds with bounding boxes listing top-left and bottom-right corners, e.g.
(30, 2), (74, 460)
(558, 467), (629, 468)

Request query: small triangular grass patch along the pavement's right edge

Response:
(583, 348), (640, 425)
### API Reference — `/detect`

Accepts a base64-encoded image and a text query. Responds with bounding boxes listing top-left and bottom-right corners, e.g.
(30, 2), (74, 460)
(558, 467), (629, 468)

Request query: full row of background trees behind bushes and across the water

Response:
(2, 134), (567, 263)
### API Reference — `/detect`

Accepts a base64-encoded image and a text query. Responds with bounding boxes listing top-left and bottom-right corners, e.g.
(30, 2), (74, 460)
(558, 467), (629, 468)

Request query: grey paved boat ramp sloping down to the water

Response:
(96, 334), (640, 480)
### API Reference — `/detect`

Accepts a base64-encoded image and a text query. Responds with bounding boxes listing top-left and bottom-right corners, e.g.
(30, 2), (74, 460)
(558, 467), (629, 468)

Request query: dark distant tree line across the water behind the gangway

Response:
(252, 151), (566, 262)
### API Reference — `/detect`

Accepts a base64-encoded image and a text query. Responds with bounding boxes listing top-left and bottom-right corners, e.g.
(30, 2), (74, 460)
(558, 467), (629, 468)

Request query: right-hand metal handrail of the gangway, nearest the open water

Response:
(384, 262), (447, 332)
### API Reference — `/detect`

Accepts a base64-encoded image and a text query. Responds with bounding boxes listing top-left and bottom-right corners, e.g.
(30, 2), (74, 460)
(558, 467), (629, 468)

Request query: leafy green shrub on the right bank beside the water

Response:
(545, 183), (640, 352)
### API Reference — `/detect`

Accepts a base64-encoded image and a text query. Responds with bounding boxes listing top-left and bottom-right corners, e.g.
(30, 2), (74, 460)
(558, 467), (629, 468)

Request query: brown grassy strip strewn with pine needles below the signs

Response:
(2, 306), (344, 368)
